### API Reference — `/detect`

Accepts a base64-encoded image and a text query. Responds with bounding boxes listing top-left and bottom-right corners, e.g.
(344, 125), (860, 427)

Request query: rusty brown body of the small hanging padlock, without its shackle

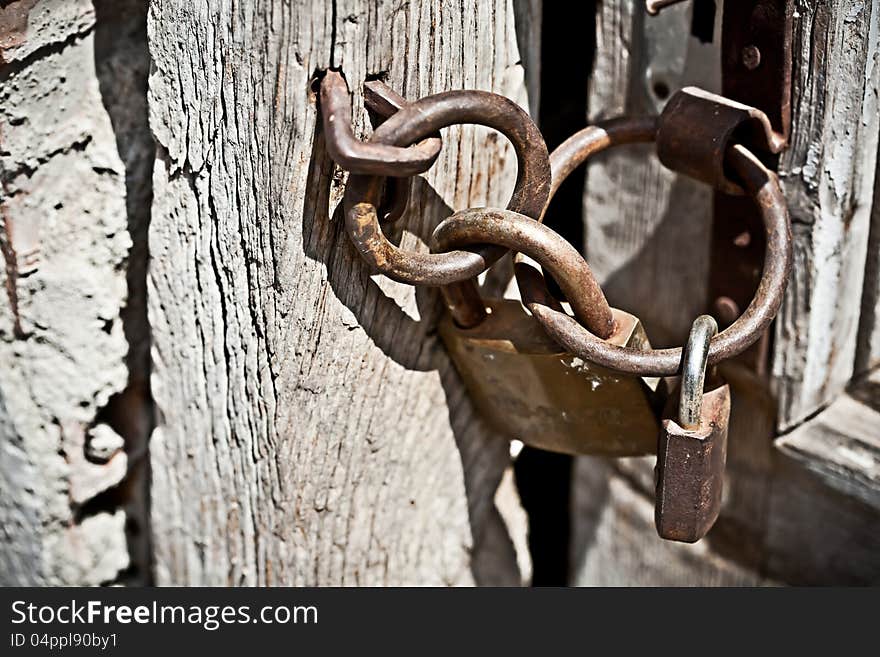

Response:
(654, 381), (730, 543)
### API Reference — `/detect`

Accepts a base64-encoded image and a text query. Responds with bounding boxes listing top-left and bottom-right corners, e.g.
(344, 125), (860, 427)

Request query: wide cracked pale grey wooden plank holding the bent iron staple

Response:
(150, 0), (526, 585)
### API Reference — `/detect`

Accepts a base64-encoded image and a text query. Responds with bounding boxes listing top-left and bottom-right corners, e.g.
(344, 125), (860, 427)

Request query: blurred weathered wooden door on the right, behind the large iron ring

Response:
(572, 0), (880, 585)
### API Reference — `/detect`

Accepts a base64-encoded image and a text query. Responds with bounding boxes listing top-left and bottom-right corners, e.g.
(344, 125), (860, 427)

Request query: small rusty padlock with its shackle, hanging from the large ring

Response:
(654, 315), (730, 543)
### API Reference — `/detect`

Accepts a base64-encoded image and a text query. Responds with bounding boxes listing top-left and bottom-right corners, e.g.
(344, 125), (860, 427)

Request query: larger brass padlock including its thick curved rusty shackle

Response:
(434, 209), (665, 457)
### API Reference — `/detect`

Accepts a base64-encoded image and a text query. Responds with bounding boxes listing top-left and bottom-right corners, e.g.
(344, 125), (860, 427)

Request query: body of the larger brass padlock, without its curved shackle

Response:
(439, 299), (662, 456)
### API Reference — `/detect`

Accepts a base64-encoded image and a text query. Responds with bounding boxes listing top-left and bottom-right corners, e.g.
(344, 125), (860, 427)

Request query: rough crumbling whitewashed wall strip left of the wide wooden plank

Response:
(0, 0), (153, 585)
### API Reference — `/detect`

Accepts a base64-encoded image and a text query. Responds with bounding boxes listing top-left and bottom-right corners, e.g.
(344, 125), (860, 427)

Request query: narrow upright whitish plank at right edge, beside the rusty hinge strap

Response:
(773, 0), (880, 430)
